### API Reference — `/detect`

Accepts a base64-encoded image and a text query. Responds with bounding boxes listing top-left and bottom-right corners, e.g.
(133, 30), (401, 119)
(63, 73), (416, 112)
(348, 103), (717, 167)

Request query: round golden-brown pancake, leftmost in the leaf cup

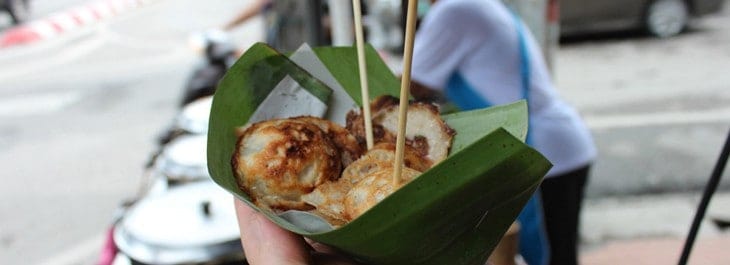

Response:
(232, 116), (342, 210)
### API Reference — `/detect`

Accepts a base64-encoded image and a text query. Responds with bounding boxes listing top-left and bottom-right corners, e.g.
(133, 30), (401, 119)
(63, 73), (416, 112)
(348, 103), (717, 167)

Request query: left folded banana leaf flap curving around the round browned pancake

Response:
(207, 44), (332, 196)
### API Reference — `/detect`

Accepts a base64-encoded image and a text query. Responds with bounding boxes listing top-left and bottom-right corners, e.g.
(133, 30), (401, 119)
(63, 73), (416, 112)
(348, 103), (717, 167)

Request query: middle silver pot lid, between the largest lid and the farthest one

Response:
(156, 135), (210, 179)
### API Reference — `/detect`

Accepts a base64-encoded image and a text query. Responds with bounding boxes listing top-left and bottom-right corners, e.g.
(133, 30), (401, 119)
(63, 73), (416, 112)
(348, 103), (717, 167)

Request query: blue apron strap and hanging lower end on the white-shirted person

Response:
(512, 11), (550, 265)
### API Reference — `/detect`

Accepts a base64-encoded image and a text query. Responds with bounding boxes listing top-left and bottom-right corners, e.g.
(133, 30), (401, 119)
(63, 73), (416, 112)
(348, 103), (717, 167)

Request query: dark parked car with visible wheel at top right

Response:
(560, 0), (724, 37)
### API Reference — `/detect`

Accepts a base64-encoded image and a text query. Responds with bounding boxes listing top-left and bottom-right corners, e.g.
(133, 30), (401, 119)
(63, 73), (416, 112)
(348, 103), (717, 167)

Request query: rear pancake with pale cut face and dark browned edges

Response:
(346, 96), (455, 165)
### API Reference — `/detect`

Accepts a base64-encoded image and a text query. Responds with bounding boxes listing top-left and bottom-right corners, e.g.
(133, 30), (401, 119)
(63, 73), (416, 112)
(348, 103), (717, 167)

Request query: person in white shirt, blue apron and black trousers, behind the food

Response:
(411, 0), (597, 265)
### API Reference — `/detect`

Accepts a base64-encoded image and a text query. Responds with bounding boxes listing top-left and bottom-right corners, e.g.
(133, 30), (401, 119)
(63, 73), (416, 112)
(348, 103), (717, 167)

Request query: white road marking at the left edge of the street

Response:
(0, 91), (82, 117)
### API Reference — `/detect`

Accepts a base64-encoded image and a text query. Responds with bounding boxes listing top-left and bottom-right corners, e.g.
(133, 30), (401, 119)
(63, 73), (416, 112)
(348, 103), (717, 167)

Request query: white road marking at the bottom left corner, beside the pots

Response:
(37, 233), (106, 265)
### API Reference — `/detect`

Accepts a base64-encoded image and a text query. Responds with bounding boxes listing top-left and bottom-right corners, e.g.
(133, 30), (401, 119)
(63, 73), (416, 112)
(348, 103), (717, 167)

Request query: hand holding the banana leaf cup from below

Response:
(235, 200), (358, 265)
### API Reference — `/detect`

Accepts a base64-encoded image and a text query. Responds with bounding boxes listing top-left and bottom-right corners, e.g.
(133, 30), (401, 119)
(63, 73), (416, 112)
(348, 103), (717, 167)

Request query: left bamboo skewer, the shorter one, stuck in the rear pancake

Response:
(352, 0), (374, 150)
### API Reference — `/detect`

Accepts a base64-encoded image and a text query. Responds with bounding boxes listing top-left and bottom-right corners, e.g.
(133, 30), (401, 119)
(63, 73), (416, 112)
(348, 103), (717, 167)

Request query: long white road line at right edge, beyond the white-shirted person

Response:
(585, 108), (730, 129)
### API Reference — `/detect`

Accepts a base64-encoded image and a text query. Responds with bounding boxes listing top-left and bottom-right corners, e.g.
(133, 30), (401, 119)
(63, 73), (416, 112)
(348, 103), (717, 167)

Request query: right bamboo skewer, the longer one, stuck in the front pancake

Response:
(393, 0), (418, 187)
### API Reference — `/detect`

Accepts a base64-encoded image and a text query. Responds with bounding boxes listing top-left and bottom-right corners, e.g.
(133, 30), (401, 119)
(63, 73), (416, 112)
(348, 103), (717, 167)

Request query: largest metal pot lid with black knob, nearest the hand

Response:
(117, 181), (240, 246)
